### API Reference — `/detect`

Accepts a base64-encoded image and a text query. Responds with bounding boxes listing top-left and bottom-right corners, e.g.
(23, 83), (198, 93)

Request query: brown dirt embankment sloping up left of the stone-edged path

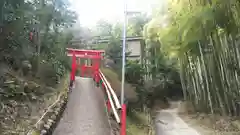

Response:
(0, 65), (68, 135)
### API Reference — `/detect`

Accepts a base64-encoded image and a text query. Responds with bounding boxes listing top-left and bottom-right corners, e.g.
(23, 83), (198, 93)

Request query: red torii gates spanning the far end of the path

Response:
(67, 48), (104, 86)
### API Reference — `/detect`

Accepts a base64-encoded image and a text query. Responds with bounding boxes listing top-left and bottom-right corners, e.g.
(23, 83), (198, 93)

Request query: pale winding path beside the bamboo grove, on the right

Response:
(156, 102), (200, 135)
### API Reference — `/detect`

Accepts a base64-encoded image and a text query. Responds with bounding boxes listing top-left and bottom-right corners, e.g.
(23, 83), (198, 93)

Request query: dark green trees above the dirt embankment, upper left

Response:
(0, 0), (76, 84)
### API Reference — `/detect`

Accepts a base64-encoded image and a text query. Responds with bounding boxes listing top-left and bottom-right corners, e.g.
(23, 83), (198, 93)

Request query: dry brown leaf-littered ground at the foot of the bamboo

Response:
(179, 102), (240, 135)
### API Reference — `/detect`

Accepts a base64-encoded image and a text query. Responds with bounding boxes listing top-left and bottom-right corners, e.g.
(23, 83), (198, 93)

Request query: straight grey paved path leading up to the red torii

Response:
(53, 77), (111, 135)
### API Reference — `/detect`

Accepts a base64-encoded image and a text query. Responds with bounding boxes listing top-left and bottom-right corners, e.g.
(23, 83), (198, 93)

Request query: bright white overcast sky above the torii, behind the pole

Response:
(70, 0), (163, 26)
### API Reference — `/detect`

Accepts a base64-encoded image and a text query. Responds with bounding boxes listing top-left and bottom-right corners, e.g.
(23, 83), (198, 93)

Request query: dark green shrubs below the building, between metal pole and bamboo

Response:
(125, 54), (182, 107)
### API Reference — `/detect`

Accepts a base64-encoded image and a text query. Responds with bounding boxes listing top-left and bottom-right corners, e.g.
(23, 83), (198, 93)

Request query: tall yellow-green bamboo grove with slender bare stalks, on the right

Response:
(145, 0), (240, 115)
